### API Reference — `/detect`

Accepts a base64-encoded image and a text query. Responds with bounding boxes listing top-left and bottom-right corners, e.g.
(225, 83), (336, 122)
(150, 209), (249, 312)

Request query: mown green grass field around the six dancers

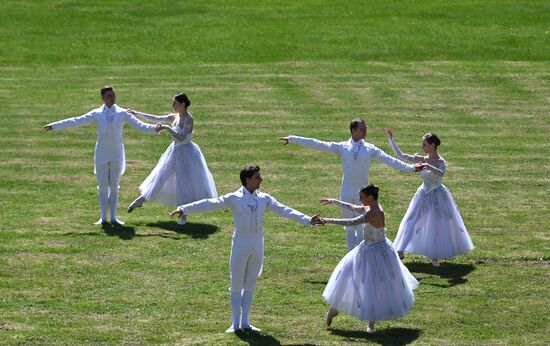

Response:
(0, 1), (550, 345)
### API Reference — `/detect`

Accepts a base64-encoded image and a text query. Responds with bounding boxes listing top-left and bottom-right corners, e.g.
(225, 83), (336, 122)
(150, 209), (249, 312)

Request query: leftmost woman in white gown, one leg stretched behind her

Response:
(128, 94), (218, 225)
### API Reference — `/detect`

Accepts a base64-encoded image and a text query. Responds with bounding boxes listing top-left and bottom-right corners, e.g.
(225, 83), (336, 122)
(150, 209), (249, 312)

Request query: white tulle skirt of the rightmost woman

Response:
(394, 185), (474, 259)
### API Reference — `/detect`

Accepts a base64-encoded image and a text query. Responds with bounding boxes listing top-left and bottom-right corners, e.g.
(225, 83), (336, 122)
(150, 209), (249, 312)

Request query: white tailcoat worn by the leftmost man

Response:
(52, 104), (156, 174)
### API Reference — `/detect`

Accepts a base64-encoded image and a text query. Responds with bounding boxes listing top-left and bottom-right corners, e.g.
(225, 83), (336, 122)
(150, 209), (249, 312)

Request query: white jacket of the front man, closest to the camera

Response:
(178, 186), (311, 238)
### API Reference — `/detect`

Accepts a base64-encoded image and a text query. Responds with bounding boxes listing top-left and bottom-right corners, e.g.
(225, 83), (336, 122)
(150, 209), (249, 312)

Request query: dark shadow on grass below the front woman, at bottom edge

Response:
(330, 328), (420, 345)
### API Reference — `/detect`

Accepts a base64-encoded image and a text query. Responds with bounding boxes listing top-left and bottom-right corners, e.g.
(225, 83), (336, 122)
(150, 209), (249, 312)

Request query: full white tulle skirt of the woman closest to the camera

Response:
(323, 239), (418, 322)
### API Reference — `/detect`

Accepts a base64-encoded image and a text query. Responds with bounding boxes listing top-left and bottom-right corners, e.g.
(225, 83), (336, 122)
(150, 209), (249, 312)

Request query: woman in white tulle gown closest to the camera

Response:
(321, 184), (418, 333)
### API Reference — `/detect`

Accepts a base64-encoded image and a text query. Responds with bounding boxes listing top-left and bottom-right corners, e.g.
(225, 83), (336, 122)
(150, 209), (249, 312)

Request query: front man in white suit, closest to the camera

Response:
(170, 166), (322, 333)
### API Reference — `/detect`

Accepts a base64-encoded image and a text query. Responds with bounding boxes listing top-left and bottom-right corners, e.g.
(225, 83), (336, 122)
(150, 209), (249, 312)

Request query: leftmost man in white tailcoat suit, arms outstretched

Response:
(43, 86), (158, 225)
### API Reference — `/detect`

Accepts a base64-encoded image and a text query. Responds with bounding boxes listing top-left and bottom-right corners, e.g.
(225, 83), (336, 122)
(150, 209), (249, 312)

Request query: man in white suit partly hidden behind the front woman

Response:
(279, 119), (422, 251)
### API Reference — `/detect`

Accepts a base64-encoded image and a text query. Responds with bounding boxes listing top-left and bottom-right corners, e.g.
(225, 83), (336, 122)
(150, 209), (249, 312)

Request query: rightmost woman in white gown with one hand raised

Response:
(384, 129), (474, 266)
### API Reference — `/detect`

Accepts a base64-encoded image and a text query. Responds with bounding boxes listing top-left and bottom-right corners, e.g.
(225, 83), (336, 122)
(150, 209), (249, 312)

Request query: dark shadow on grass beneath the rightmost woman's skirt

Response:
(405, 262), (475, 287)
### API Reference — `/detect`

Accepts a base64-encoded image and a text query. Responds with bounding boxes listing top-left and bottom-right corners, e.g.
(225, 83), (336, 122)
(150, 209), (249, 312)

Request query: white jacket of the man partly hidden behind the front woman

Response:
(288, 136), (414, 192)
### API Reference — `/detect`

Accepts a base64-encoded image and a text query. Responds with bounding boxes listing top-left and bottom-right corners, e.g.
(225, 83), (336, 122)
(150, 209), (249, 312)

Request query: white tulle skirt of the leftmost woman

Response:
(139, 141), (218, 206)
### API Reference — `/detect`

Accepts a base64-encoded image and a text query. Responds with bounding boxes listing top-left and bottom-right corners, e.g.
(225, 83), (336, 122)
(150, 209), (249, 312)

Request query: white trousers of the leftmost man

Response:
(95, 161), (122, 221)
